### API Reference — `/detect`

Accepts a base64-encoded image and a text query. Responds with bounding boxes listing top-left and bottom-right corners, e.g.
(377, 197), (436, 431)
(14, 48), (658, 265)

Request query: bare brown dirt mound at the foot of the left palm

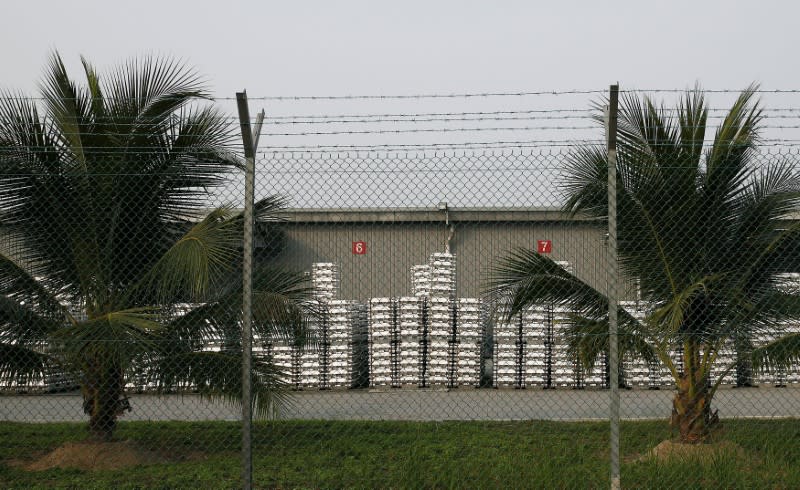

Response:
(11, 440), (205, 471)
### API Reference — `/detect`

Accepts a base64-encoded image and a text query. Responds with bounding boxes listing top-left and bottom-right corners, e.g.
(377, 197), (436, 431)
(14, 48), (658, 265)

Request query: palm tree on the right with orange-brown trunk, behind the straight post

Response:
(492, 87), (800, 443)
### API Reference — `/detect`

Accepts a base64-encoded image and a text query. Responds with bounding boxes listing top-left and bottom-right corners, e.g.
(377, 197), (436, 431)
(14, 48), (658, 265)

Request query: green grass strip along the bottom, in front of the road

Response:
(0, 419), (800, 489)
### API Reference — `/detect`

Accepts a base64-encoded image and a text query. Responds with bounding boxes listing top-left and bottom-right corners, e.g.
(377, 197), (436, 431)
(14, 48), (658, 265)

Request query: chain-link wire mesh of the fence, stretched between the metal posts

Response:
(0, 79), (800, 488)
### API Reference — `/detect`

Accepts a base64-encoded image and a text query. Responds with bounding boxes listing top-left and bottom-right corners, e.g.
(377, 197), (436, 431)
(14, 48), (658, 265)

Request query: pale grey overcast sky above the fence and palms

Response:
(0, 0), (800, 207)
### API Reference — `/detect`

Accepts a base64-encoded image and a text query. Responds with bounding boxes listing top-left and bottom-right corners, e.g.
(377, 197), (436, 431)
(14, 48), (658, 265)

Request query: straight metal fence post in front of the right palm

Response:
(606, 85), (620, 490)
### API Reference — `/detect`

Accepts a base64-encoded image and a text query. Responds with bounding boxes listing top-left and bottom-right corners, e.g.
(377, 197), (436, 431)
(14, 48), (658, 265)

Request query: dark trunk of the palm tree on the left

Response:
(83, 359), (123, 441)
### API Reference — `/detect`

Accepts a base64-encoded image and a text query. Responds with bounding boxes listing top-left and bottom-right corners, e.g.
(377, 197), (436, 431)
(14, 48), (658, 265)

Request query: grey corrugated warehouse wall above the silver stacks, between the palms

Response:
(268, 212), (606, 301)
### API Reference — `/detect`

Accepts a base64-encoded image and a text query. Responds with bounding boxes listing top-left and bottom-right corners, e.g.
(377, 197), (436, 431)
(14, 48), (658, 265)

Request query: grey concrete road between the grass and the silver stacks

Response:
(0, 386), (800, 422)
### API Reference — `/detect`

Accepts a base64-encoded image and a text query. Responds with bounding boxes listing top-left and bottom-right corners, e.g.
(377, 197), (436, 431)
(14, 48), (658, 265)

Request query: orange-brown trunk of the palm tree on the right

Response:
(671, 344), (719, 444)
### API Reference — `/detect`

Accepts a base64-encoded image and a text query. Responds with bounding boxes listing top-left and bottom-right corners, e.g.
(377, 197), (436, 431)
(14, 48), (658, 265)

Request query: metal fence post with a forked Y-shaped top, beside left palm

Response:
(236, 91), (264, 490)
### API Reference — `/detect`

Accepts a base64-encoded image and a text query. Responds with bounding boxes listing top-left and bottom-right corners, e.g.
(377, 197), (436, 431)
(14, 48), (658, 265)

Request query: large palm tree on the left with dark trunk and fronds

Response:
(0, 54), (310, 440)
